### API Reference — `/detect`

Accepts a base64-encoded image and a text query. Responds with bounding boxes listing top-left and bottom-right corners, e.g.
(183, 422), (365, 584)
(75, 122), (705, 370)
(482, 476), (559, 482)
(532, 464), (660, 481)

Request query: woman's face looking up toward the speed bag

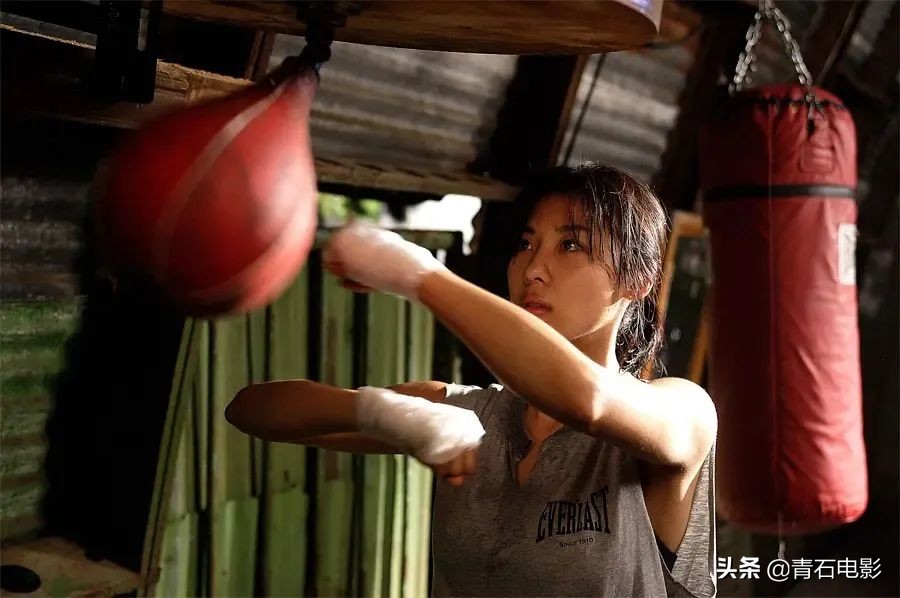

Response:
(506, 195), (626, 341)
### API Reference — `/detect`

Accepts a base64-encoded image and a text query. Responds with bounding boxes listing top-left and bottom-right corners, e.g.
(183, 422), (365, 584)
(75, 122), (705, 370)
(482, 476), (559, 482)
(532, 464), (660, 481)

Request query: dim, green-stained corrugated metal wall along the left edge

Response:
(0, 119), (96, 539)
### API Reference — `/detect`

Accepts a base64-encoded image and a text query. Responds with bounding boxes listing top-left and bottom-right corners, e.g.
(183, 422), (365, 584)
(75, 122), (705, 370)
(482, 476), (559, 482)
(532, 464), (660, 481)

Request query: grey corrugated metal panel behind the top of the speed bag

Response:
(271, 35), (516, 171)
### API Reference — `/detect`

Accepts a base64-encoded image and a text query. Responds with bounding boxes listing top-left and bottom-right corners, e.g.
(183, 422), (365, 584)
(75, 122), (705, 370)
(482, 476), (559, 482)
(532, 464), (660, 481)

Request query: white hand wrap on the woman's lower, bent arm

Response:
(356, 386), (484, 465)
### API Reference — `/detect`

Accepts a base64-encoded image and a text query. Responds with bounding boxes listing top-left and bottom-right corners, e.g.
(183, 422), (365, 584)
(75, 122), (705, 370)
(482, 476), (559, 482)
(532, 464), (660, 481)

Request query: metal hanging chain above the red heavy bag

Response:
(728, 0), (820, 112)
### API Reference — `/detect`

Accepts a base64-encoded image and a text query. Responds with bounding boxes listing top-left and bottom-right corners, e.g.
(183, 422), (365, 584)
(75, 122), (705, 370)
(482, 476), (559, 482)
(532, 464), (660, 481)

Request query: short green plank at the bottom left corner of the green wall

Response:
(152, 513), (200, 598)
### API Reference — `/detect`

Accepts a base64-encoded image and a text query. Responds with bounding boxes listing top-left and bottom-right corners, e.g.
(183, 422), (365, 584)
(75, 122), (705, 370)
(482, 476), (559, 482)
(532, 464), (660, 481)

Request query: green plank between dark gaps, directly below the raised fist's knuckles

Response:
(315, 276), (354, 596)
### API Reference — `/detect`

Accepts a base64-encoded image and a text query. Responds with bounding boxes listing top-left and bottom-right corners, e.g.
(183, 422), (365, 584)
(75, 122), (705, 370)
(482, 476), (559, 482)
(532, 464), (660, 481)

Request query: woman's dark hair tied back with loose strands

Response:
(511, 163), (668, 376)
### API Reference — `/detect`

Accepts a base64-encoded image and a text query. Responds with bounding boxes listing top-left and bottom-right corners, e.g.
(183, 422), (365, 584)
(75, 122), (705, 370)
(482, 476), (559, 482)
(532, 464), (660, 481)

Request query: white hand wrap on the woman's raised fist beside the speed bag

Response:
(323, 220), (445, 299)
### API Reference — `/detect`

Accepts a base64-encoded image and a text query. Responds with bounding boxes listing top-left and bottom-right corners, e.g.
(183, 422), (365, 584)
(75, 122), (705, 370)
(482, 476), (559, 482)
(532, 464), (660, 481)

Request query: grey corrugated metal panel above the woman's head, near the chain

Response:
(559, 4), (702, 181)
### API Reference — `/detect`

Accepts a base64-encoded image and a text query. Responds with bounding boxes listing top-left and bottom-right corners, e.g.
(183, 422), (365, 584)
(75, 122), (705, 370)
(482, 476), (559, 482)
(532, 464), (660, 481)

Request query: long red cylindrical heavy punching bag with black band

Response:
(700, 85), (868, 534)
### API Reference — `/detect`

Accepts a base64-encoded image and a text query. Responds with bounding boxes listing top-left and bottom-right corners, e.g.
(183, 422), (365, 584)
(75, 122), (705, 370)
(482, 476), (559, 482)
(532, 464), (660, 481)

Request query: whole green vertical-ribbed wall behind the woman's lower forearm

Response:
(151, 241), (458, 597)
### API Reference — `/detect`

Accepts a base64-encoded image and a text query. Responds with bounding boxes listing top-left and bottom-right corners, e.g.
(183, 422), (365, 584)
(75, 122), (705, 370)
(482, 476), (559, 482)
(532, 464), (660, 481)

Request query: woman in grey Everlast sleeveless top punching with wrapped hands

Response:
(226, 165), (716, 596)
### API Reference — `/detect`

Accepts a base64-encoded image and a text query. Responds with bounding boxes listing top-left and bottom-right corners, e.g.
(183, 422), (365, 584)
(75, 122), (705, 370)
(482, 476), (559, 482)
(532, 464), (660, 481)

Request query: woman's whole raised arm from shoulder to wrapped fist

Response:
(323, 222), (716, 471)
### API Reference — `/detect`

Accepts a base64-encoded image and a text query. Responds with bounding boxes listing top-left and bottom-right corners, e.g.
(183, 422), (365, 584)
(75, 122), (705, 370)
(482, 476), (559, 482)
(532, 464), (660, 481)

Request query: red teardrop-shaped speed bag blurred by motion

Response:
(96, 70), (317, 315)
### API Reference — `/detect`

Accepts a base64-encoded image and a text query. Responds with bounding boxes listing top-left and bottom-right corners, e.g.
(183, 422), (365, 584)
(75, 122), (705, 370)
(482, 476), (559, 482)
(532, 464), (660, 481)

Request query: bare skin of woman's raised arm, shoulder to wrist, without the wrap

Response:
(418, 270), (717, 468)
